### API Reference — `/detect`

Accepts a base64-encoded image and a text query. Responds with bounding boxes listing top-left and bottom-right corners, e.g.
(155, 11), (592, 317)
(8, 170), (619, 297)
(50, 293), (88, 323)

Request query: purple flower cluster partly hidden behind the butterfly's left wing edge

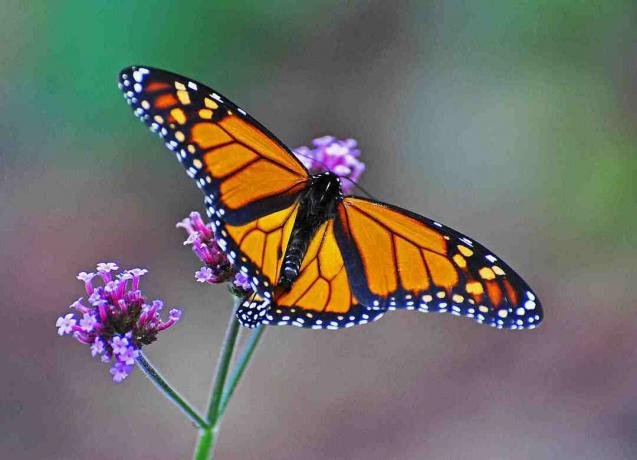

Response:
(177, 211), (250, 291)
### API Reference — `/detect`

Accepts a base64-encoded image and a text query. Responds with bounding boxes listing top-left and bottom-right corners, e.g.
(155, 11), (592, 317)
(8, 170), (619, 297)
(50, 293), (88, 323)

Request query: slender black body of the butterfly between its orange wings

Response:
(278, 172), (343, 289)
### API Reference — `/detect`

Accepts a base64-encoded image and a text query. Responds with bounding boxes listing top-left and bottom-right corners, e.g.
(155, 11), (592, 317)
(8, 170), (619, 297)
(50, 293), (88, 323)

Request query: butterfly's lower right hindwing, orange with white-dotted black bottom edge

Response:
(237, 219), (383, 329)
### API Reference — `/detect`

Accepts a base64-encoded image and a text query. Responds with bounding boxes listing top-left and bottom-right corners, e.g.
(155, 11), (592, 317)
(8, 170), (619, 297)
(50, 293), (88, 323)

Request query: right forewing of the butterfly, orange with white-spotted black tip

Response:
(334, 197), (542, 329)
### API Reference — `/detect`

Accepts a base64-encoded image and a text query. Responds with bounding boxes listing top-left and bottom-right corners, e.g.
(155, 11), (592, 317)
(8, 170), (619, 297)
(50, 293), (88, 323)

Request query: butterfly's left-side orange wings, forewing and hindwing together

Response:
(119, 67), (309, 297)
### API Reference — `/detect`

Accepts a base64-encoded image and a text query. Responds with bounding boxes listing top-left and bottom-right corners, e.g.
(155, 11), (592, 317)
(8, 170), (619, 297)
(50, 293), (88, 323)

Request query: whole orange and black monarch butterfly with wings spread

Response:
(119, 66), (543, 329)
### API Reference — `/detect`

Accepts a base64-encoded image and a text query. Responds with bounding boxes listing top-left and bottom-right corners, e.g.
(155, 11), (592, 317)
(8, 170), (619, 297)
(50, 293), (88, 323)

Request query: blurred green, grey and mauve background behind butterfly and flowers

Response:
(0, 0), (637, 460)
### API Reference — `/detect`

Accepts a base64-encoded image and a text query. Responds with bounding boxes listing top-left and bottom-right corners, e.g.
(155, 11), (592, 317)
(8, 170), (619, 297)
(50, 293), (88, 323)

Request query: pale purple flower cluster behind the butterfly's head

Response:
(294, 136), (365, 193)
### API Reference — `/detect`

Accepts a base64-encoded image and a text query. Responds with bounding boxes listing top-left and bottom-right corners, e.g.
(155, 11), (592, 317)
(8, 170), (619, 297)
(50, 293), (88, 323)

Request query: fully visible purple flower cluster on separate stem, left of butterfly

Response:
(55, 262), (182, 383)
